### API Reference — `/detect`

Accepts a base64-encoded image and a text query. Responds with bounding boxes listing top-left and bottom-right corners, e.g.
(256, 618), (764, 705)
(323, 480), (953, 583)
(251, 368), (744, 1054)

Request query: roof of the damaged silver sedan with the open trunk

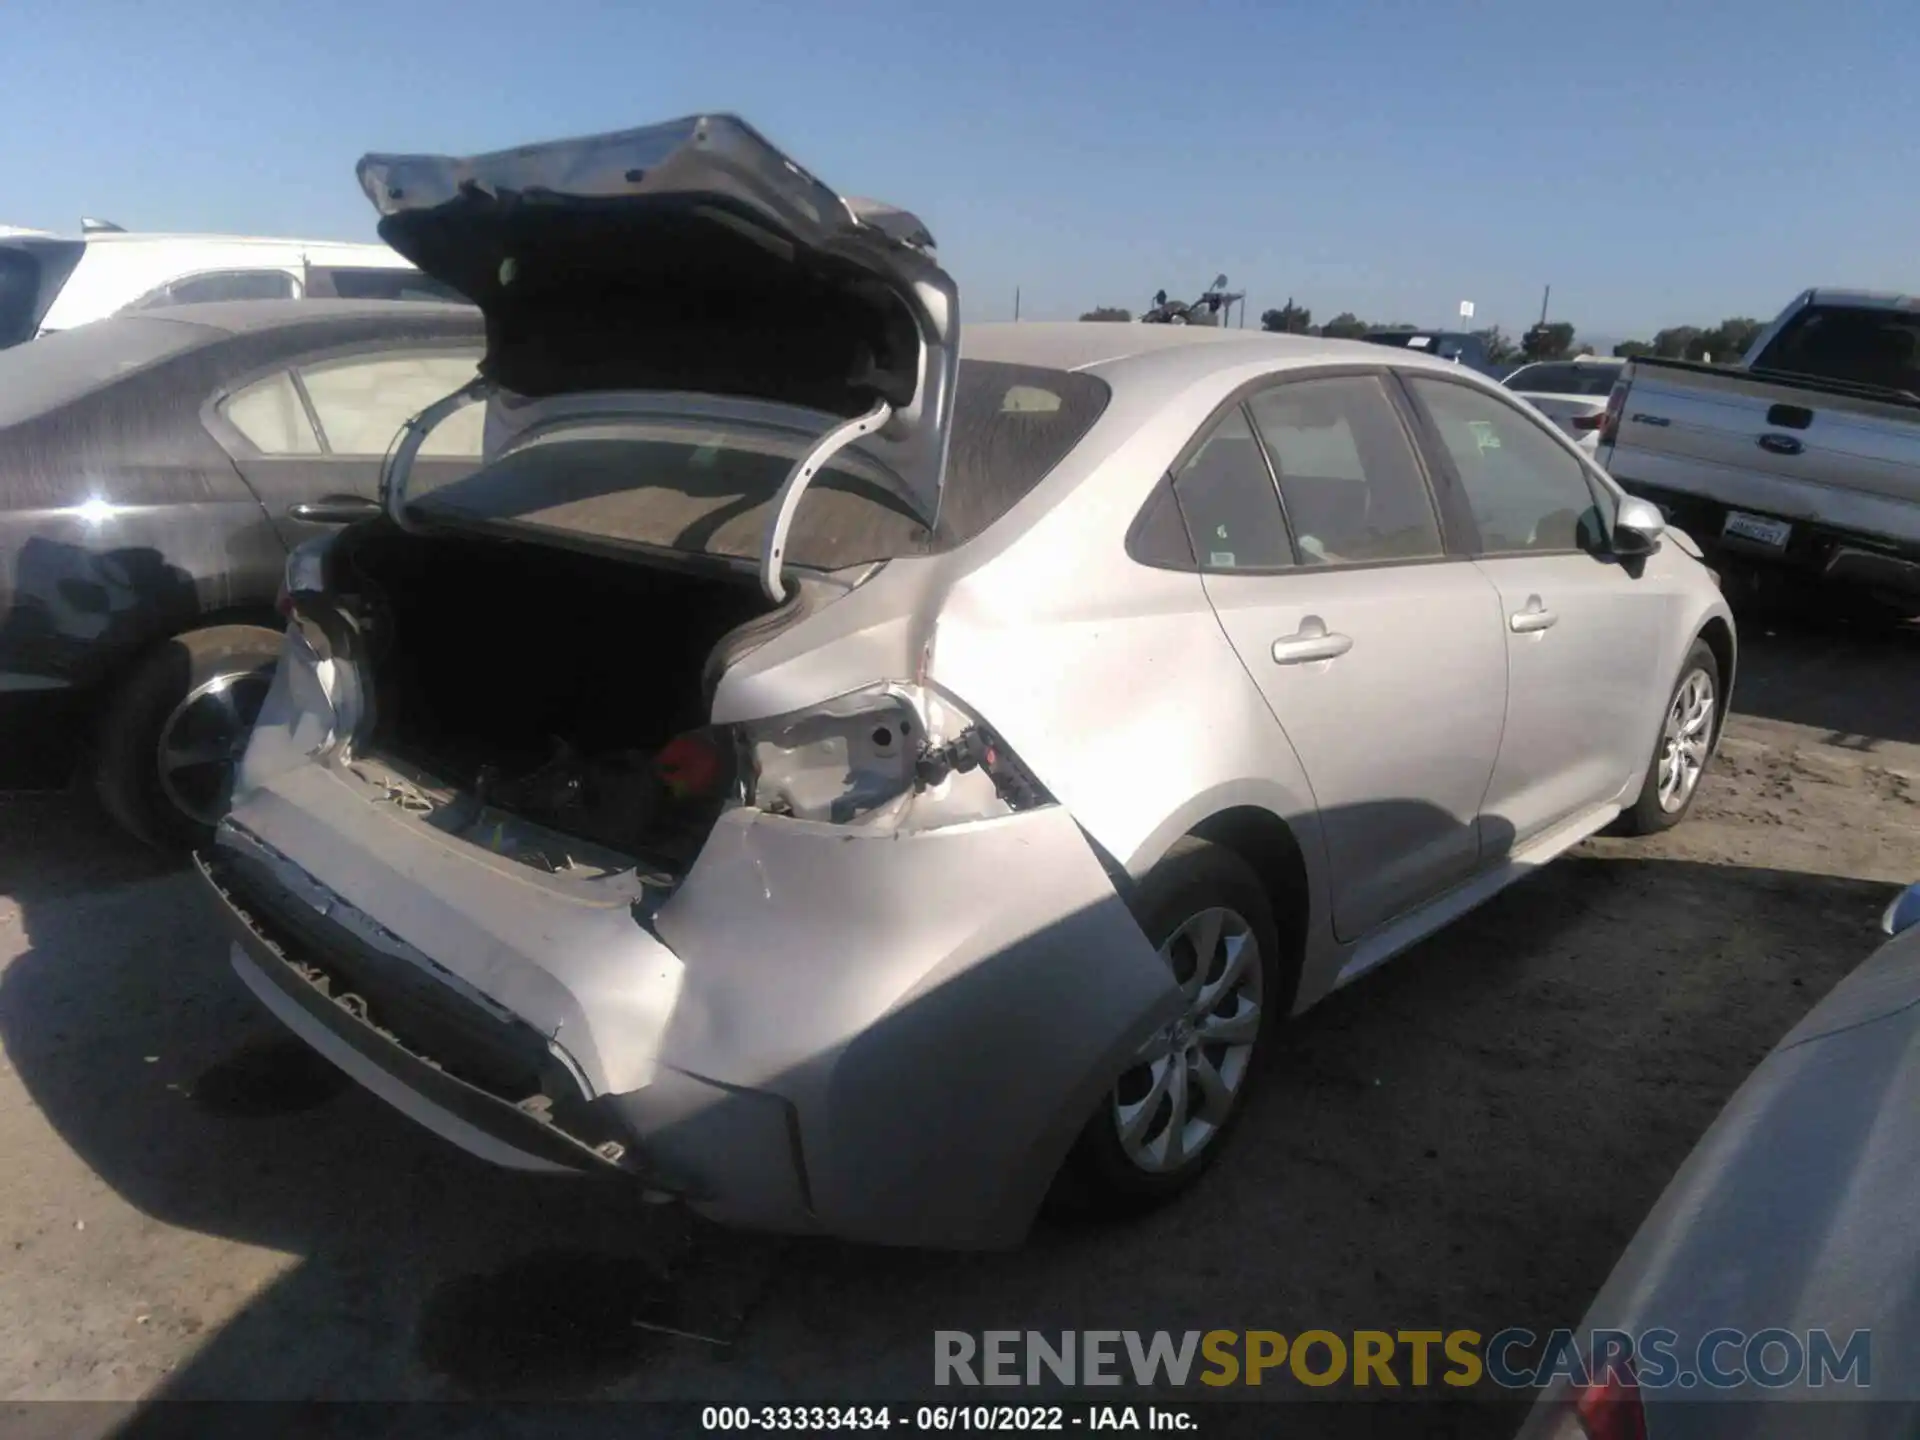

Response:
(960, 321), (1459, 382)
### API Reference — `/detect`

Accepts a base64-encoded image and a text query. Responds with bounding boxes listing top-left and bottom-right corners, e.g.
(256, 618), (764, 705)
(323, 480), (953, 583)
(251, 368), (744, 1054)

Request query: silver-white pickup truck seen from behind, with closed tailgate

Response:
(1597, 290), (1920, 616)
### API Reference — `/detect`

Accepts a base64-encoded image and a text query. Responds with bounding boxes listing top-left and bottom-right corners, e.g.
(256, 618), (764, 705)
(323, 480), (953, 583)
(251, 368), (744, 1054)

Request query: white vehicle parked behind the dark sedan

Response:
(0, 221), (459, 348)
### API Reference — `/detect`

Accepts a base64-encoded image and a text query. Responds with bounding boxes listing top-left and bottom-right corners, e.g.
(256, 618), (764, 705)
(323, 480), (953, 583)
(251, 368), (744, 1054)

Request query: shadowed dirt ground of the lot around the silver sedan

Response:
(0, 610), (1920, 1434)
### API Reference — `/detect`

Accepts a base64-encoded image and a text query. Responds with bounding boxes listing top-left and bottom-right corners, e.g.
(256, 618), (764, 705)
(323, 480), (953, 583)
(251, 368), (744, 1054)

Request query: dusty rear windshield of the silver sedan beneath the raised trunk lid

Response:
(409, 361), (1110, 570)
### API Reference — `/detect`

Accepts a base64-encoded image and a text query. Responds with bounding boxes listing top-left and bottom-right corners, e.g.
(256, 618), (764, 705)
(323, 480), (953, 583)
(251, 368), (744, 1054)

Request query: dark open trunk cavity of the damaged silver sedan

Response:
(332, 526), (791, 866)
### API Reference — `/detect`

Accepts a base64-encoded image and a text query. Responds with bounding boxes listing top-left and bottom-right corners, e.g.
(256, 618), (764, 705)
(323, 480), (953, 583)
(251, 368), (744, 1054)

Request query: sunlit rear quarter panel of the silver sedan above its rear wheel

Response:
(714, 346), (1344, 1008)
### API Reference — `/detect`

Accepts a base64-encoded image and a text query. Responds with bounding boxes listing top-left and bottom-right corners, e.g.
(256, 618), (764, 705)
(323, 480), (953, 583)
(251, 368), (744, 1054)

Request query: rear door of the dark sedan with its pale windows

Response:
(215, 348), (484, 545)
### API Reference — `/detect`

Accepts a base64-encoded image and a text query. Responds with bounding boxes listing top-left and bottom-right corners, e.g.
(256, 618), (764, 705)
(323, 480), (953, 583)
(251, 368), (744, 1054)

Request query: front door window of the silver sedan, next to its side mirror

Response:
(1405, 374), (1605, 555)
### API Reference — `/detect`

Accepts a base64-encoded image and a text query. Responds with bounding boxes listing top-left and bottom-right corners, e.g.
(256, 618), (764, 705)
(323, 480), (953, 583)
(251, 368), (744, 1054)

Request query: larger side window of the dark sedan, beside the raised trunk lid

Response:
(300, 351), (486, 459)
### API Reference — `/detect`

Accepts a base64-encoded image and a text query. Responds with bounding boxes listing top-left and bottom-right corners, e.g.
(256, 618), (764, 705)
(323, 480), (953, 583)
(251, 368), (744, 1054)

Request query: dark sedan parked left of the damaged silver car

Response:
(0, 301), (480, 847)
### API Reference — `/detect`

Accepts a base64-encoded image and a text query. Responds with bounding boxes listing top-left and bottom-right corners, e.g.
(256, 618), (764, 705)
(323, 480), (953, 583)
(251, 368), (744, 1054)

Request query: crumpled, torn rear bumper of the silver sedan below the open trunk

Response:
(202, 762), (1179, 1248)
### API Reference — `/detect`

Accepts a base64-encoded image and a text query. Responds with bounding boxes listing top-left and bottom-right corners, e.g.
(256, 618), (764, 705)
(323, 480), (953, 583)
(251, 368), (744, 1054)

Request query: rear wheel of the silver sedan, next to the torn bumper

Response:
(1048, 835), (1292, 1215)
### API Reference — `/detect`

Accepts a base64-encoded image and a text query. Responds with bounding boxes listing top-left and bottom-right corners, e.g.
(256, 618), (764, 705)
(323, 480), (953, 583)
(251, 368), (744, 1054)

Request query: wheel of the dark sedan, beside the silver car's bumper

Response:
(94, 626), (280, 854)
